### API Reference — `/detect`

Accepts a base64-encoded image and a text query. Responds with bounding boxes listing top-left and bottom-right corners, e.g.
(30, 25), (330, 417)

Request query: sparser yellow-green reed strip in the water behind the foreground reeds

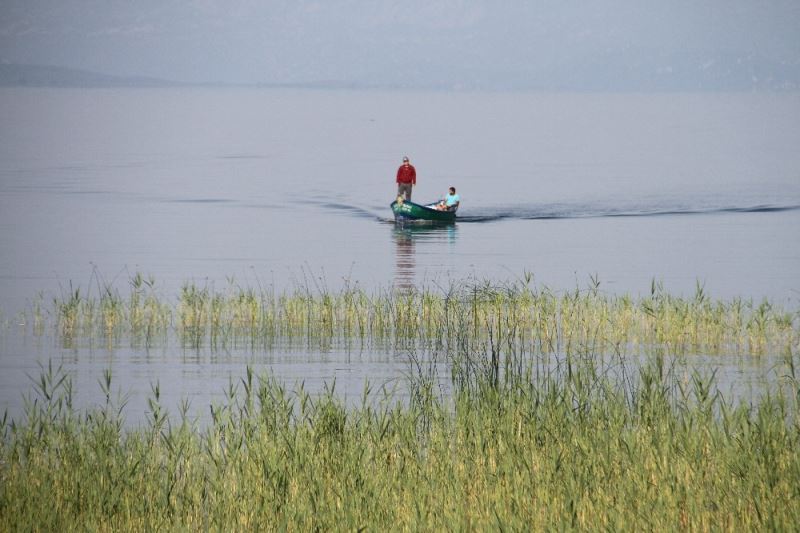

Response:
(32, 275), (800, 355)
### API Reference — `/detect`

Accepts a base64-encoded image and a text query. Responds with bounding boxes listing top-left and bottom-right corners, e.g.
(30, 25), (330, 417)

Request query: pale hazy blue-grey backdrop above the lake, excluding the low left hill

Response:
(0, 0), (800, 90)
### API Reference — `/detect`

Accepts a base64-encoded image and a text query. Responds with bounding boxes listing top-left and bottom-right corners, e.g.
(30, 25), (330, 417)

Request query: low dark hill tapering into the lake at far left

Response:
(0, 63), (180, 87)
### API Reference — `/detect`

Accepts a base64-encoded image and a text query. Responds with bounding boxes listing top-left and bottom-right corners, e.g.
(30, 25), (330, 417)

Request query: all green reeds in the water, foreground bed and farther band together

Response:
(0, 276), (800, 530)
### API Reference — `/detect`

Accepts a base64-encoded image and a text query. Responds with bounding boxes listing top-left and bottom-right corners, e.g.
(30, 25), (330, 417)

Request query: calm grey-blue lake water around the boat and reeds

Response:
(0, 88), (800, 422)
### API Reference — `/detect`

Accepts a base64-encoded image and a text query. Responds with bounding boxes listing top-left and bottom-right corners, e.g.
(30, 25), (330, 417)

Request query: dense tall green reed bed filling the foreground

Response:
(0, 357), (800, 531)
